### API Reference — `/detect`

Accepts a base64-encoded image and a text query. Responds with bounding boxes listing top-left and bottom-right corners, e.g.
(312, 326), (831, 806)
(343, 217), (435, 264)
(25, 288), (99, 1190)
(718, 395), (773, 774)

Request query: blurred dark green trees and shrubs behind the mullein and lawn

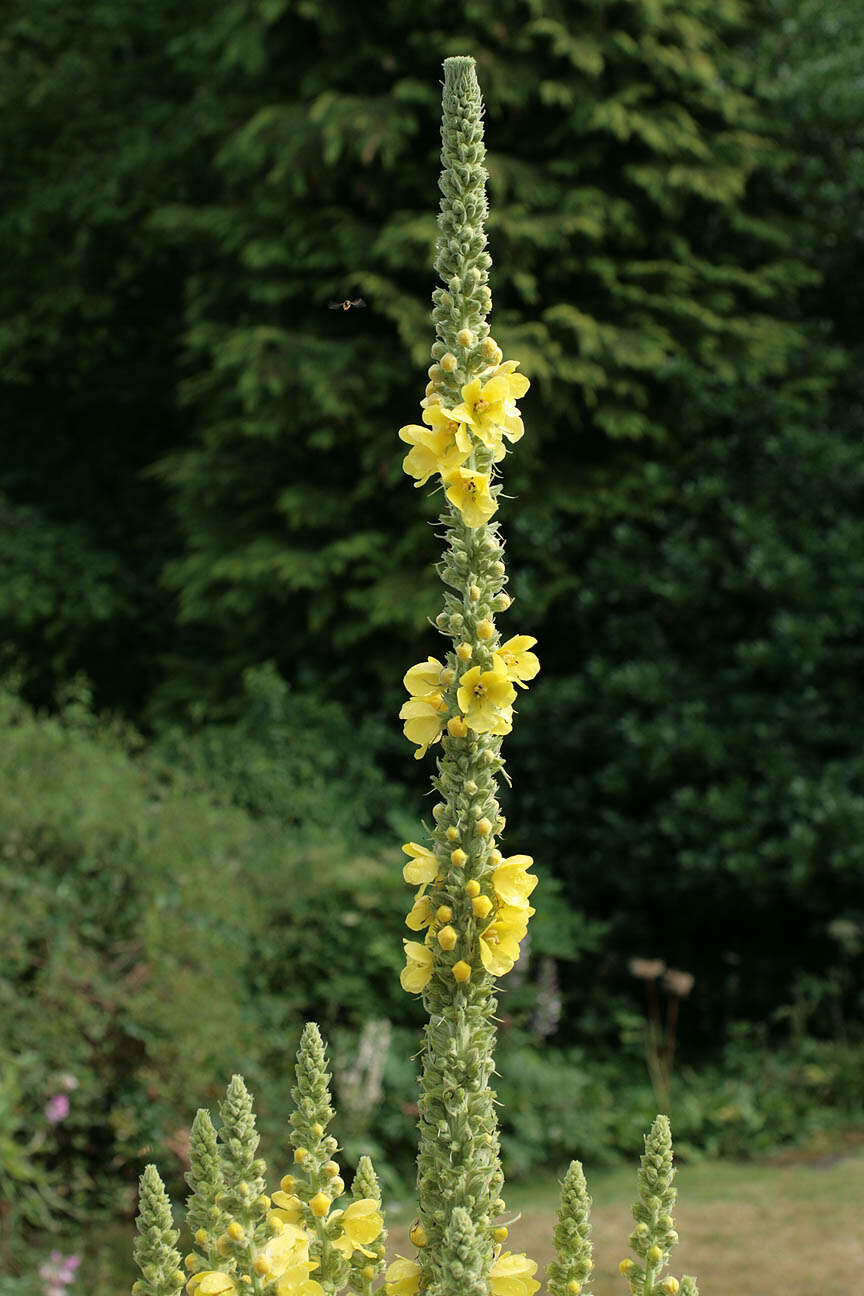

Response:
(0, 0), (864, 1296)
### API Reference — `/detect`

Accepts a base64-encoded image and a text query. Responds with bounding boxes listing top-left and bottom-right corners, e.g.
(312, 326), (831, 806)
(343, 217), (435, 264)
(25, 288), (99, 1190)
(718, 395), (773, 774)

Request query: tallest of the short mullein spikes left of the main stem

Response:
(288, 1021), (351, 1296)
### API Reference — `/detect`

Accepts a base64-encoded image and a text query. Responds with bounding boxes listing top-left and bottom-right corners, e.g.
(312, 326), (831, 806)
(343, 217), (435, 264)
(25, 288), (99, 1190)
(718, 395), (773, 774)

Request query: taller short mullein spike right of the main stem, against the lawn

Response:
(619, 1116), (694, 1296)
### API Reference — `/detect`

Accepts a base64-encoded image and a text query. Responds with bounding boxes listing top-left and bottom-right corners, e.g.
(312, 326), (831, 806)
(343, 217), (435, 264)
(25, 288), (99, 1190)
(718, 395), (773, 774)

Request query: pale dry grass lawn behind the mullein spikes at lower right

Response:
(390, 1151), (864, 1296)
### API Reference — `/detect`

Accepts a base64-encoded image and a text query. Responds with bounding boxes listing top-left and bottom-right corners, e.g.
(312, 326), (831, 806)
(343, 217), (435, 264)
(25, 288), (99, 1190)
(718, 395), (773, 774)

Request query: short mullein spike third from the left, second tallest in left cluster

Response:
(216, 1076), (271, 1296)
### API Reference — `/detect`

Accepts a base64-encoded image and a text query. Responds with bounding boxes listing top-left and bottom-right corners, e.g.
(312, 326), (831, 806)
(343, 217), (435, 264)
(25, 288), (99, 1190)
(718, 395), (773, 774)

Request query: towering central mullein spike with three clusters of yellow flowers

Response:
(389, 57), (540, 1296)
